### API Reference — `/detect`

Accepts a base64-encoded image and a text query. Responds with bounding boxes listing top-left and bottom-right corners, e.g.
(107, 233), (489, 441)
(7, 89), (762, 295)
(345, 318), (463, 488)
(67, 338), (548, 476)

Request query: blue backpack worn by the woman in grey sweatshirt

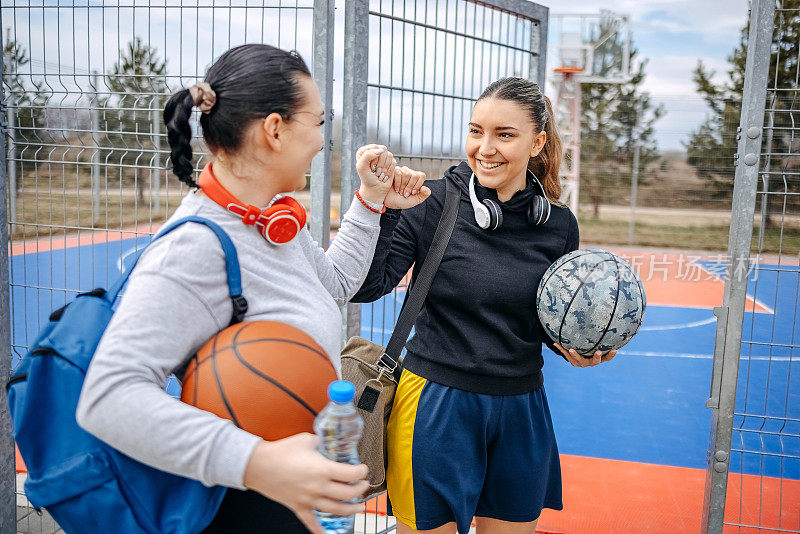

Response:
(7, 216), (247, 534)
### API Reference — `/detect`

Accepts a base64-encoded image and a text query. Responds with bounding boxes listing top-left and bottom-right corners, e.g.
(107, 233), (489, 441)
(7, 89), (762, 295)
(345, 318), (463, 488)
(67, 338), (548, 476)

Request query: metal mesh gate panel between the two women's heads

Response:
(341, 0), (548, 344)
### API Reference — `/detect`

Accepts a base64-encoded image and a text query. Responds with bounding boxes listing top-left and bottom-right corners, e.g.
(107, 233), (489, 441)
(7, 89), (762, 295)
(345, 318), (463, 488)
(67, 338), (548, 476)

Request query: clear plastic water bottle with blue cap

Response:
(314, 380), (364, 534)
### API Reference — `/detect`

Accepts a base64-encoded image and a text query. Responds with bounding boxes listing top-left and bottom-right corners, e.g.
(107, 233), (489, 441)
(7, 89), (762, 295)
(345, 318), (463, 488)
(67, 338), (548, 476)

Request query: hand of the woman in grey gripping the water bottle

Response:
(244, 433), (369, 534)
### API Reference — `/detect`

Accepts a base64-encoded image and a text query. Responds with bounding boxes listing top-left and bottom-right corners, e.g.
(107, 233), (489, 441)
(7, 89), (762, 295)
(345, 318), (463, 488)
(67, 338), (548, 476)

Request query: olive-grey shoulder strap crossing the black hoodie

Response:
(378, 178), (461, 372)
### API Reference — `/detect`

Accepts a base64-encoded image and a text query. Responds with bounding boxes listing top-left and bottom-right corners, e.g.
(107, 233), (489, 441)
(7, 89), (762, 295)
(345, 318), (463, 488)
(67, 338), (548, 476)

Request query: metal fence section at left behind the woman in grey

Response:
(0, 0), (334, 532)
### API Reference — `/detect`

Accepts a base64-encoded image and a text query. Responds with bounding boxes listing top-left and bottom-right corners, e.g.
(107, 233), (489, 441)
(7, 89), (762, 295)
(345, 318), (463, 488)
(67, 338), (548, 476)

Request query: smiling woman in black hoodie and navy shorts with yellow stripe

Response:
(353, 78), (615, 534)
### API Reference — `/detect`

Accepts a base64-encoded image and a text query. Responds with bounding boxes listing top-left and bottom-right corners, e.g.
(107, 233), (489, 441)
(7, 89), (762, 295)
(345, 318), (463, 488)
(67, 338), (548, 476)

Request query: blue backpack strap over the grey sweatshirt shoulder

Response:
(106, 215), (247, 324)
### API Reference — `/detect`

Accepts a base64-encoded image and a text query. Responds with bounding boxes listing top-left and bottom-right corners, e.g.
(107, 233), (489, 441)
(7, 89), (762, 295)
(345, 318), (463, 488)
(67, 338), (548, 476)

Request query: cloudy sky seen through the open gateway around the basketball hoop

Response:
(539, 0), (748, 150)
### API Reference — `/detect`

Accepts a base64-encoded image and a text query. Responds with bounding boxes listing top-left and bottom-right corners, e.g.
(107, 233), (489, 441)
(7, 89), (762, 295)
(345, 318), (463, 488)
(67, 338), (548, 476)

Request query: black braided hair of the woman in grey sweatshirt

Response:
(164, 44), (311, 187)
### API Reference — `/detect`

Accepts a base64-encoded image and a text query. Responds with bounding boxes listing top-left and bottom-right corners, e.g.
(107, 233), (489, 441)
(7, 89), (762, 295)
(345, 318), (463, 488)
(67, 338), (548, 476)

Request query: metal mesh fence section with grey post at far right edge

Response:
(703, 0), (800, 533)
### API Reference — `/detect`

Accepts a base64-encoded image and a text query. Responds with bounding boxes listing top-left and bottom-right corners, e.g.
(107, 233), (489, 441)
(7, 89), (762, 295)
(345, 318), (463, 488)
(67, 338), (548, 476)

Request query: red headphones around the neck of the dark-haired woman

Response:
(197, 163), (306, 245)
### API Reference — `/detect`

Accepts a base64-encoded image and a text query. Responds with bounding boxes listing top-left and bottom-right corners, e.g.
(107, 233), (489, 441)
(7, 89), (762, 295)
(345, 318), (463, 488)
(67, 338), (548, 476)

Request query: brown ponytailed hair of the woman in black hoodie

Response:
(478, 77), (562, 202)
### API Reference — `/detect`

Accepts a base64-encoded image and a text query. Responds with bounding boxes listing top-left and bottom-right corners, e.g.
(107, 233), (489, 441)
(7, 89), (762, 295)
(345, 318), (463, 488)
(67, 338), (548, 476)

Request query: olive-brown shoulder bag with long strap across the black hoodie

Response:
(342, 178), (461, 499)
